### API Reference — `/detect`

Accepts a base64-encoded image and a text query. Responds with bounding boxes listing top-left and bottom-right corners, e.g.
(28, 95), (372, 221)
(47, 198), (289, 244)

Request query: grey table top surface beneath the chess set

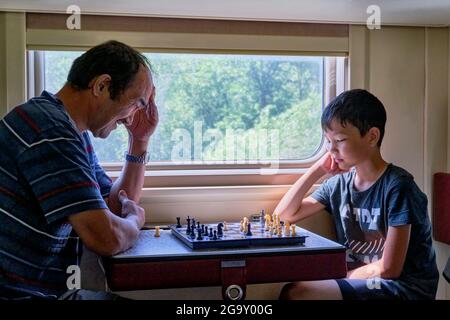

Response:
(109, 228), (345, 262)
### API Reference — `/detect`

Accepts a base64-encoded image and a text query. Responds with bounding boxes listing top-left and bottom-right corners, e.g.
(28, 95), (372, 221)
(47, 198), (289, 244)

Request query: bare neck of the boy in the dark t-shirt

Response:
(354, 152), (388, 191)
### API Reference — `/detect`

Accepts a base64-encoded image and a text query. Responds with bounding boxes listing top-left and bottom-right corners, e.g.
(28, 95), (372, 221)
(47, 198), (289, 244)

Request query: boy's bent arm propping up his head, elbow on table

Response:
(274, 152), (342, 223)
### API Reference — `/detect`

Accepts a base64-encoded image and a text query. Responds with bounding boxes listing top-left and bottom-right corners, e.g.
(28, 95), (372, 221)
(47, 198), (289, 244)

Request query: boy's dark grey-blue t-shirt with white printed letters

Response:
(311, 164), (439, 298)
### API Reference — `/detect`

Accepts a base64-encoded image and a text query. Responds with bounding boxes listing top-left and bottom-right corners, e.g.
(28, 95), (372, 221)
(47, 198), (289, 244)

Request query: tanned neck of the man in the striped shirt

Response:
(56, 85), (89, 132)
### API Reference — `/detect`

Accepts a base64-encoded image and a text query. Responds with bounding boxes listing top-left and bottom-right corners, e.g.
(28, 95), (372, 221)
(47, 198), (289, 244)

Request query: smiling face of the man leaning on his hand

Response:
(90, 66), (153, 139)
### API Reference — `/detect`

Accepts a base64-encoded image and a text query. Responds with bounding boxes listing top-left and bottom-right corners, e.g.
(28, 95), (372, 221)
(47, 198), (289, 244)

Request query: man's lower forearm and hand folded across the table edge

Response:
(68, 191), (145, 256)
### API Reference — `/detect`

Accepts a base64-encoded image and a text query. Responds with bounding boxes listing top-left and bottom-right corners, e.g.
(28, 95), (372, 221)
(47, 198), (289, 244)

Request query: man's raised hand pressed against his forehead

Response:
(125, 87), (159, 142)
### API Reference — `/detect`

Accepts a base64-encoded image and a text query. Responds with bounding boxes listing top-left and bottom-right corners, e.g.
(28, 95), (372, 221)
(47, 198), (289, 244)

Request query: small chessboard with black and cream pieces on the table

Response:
(170, 222), (307, 249)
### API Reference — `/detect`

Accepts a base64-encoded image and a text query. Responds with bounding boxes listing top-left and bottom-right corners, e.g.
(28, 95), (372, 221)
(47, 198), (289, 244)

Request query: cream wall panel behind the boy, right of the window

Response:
(349, 26), (450, 299)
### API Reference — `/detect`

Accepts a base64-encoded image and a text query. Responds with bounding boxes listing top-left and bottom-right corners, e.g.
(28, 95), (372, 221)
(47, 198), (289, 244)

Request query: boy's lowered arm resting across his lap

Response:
(347, 224), (411, 279)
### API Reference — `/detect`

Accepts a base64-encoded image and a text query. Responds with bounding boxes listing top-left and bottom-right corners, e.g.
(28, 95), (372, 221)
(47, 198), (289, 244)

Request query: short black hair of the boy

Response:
(321, 89), (386, 147)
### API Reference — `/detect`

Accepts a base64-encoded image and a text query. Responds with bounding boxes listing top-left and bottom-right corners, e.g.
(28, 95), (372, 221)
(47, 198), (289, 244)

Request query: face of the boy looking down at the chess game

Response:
(325, 120), (378, 170)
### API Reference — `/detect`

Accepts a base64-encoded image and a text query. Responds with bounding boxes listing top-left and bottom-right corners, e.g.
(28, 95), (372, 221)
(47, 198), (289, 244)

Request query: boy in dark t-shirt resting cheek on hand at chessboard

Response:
(275, 89), (439, 299)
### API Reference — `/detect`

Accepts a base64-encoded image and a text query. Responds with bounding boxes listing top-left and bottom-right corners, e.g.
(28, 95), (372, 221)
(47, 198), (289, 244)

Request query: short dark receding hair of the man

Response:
(67, 40), (151, 100)
